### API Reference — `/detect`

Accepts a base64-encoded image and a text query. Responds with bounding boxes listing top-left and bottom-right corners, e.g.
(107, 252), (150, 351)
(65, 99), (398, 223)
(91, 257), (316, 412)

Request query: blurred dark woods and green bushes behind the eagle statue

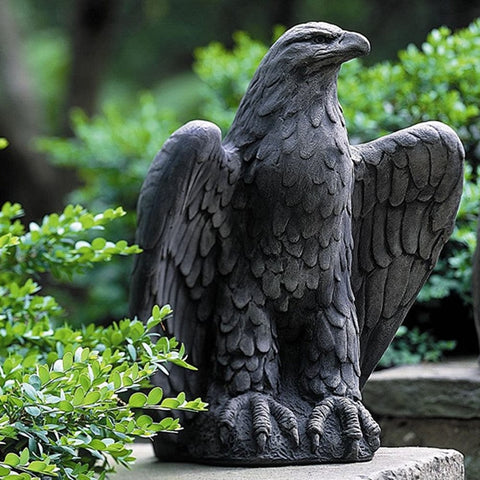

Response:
(0, 0), (480, 365)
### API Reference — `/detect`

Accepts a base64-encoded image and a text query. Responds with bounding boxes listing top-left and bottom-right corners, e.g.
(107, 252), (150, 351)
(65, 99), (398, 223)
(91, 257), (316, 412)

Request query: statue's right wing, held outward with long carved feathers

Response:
(352, 122), (464, 387)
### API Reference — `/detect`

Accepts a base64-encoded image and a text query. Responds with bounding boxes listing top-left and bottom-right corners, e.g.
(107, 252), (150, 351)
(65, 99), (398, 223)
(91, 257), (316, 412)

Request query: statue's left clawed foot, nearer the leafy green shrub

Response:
(219, 393), (299, 453)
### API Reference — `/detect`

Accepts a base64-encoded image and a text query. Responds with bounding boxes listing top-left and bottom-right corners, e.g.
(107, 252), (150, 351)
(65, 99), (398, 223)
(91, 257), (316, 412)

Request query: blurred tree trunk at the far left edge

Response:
(0, 0), (68, 217)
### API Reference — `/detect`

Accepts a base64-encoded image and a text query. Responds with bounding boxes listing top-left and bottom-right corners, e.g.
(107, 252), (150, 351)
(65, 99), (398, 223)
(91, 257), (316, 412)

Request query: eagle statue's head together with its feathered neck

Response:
(225, 22), (370, 145)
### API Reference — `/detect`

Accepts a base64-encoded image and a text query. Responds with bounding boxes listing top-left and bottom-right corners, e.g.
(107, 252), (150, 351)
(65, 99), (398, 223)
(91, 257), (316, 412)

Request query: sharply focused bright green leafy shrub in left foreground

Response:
(0, 203), (205, 480)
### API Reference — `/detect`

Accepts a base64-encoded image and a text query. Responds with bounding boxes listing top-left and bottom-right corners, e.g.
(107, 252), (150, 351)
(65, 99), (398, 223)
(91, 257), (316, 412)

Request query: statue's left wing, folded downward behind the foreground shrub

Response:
(130, 121), (236, 396)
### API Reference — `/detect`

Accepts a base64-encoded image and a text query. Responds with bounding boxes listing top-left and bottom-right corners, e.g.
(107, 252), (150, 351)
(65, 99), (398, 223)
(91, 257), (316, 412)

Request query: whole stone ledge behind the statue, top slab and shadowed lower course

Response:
(363, 358), (480, 480)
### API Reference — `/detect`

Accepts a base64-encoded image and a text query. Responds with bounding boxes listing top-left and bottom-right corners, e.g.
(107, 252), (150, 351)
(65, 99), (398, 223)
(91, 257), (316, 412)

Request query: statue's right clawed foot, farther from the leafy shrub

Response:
(307, 396), (380, 460)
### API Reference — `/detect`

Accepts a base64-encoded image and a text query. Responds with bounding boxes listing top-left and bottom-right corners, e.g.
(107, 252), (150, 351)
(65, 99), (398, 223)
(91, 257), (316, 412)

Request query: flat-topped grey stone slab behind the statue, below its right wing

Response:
(363, 358), (480, 419)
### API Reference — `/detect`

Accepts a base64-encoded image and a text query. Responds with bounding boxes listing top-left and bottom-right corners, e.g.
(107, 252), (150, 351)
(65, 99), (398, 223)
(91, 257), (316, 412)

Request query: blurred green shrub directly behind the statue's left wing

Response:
(38, 94), (179, 324)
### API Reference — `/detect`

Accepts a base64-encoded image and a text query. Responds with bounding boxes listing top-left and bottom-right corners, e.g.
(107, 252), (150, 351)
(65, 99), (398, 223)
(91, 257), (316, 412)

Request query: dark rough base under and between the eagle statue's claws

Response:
(154, 391), (380, 467)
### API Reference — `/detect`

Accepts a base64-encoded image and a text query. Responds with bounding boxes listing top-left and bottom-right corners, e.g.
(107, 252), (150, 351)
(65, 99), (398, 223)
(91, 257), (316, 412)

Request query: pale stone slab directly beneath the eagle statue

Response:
(111, 443), (464, 480)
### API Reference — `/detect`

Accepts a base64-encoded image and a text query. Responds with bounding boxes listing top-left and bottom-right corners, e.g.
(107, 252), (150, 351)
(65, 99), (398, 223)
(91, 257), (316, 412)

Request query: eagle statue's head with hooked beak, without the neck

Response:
(265, 22), (370, 72)
